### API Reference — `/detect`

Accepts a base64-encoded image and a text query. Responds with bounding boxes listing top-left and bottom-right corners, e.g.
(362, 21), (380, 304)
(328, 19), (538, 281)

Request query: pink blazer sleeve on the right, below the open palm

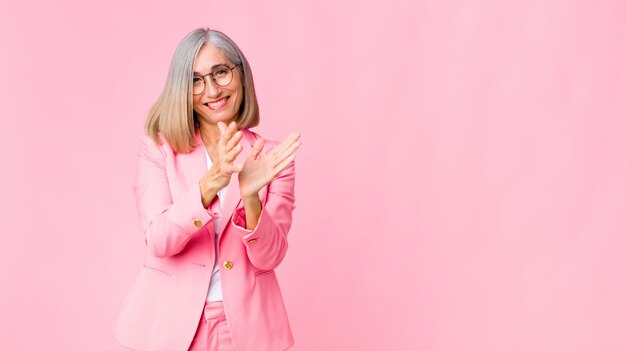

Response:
(231, 155), (296, 270)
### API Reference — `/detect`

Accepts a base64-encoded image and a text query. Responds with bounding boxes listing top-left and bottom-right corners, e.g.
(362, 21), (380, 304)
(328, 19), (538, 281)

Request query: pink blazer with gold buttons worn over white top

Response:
(114, 129), (295, 351)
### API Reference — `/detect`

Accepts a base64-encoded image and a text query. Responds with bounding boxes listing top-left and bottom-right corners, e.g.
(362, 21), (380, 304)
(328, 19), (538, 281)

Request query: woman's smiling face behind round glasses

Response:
(193, 43), (243, 124)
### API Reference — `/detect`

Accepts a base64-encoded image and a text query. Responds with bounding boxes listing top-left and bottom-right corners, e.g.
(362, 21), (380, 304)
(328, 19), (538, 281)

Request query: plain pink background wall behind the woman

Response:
(0, 0), (626, 351)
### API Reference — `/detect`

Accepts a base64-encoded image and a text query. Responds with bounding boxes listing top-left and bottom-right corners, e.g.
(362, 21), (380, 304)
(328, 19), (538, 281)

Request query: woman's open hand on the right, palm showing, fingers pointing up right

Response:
(239, 132), (302, 199)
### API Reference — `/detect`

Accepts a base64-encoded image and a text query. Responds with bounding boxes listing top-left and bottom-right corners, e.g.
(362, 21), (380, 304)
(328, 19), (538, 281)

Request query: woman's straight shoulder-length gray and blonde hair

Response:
(145, 28), (260, 152)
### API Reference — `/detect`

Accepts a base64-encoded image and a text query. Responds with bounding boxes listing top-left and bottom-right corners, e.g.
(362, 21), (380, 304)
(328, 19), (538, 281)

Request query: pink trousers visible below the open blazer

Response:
(189, 301), (235, 351)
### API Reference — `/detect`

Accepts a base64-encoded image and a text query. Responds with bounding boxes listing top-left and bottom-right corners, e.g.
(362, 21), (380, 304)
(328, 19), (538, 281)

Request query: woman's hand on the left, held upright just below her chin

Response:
(200, 121), (243, 208)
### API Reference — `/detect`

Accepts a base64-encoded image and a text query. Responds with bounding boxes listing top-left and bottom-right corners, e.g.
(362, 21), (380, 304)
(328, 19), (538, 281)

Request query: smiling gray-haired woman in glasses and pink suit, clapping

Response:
(115, 29), (301, 351)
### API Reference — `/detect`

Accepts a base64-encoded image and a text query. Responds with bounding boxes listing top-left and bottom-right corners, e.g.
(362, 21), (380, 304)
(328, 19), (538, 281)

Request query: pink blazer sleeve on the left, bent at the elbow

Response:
(134, 135), (219, 257)
